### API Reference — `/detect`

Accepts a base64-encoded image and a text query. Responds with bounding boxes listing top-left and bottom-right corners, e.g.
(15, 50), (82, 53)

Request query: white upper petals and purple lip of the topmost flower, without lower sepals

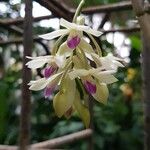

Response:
(40, 16), (102, 49)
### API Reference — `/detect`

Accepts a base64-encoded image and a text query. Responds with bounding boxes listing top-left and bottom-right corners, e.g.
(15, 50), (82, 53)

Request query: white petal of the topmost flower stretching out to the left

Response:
(39, 29), (69, 40)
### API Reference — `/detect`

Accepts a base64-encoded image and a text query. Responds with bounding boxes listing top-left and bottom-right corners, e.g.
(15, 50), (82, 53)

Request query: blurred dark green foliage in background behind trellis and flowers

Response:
(0, 0), (143, 150)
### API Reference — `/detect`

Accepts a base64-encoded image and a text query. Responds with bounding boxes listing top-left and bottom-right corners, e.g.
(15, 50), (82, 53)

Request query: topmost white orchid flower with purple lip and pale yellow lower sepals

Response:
(40, 17), (102, 55)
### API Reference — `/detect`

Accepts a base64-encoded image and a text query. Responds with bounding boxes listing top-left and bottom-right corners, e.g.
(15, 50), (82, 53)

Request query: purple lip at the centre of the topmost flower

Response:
(67, 36), (81, 49)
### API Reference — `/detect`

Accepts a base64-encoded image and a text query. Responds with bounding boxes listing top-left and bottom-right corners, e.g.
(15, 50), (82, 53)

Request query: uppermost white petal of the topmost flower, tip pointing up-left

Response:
(60, 18), (89, 31)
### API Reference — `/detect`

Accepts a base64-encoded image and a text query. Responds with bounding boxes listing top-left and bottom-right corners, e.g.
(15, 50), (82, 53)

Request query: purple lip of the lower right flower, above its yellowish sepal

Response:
(84, 81), (96, 94)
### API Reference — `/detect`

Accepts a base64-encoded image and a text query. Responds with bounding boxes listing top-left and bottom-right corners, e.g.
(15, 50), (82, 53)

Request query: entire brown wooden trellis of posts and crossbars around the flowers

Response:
(0, 0), (150, 150)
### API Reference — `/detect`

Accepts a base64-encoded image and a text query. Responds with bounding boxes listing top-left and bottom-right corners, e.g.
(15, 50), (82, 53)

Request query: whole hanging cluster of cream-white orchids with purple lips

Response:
(26, 1), (123, 127)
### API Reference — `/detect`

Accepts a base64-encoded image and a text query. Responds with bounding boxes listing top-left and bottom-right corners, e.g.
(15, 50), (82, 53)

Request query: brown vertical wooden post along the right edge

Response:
(132, 0), (150, 150)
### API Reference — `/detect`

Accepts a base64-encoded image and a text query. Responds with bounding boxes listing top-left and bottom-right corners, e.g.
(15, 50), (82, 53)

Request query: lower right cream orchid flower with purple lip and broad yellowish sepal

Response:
(69, 69), (115, 104)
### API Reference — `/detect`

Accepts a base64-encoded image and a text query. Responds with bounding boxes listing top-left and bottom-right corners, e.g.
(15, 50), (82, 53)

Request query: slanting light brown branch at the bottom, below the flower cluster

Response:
(31, 129), (92, 148)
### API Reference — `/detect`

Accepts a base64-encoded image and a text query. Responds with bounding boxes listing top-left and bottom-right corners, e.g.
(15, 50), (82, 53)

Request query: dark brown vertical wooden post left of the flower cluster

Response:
(19, 0), (33, 150)
